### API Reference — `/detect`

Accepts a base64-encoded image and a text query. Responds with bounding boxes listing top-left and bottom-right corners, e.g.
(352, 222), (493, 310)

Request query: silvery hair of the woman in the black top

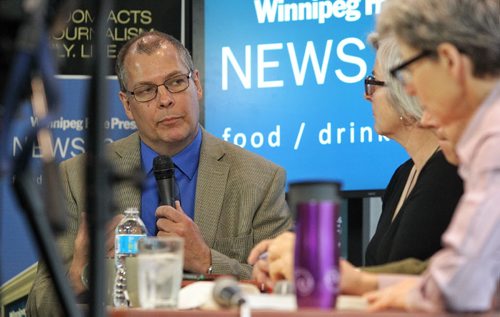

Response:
(368, 33), (422, 122)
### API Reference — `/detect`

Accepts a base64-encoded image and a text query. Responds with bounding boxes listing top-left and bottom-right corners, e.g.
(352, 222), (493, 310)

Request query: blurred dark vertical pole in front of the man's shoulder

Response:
(86, 0), (112, 317)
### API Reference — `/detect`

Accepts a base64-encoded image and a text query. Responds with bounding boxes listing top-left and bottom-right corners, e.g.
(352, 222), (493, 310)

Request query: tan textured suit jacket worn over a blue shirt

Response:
(27, 129), (291, 316)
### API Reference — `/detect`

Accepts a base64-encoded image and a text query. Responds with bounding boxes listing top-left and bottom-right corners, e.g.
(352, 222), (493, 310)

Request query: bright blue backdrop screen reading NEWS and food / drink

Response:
(204, 0), (407, 194)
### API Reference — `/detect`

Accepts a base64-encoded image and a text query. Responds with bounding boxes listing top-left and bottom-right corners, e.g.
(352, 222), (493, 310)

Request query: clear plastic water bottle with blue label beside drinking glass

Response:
(113, 208), (146, 307)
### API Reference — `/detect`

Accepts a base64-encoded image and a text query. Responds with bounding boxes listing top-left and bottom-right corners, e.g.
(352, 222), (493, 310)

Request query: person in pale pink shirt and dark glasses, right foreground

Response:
(347, 0), (500, 312)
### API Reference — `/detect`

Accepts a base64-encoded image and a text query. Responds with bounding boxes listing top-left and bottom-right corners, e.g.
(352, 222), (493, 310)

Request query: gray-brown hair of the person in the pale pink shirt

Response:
(377, 0), (500, 77)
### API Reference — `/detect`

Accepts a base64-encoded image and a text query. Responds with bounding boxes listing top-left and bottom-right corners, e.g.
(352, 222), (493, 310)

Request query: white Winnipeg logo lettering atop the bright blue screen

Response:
(254, 0), (368, 24)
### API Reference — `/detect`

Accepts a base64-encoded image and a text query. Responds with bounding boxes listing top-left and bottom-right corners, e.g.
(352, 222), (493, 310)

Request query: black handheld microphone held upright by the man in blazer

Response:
(153, 155), (175, 208)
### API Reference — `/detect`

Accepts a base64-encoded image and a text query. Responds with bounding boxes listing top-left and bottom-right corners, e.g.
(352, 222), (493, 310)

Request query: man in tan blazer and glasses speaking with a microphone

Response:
(27, 32), (291, 316)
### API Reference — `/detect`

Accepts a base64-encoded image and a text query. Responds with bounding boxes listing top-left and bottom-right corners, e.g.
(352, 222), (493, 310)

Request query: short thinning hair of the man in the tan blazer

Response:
(115, 31), (194, 91)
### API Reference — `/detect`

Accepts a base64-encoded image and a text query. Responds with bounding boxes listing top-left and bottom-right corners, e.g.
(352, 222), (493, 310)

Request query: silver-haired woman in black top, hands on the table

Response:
(248, 34), (463, 288)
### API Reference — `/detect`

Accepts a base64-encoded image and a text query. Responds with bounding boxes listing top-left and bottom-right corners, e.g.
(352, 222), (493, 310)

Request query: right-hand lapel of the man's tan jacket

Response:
(194, 129), (230, 247)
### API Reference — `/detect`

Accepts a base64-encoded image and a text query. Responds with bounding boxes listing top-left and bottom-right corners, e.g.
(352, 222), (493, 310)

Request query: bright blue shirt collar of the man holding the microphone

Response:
(141, 127), (201, 180)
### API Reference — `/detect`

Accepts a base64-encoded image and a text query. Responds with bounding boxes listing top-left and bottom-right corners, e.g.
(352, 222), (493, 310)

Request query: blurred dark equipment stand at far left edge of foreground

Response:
(0, 0), (81, 317)
